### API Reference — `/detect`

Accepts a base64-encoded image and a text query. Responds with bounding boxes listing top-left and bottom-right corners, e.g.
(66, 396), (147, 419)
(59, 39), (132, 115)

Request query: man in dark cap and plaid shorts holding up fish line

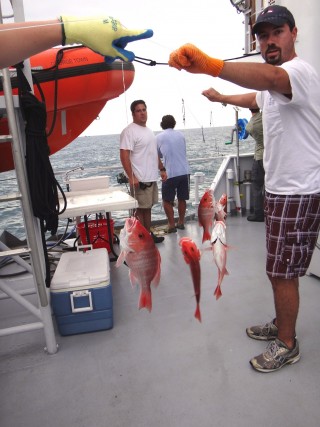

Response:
(169, 5), (320, 372)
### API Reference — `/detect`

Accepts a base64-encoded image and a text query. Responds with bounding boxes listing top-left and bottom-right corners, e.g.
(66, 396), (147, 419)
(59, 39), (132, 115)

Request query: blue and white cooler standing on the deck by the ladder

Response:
(50, 248), (113, 335)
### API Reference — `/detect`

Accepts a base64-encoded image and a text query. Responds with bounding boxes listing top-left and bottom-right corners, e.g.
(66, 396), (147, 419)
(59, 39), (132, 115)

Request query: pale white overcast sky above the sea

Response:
(2, 0), (250, 135)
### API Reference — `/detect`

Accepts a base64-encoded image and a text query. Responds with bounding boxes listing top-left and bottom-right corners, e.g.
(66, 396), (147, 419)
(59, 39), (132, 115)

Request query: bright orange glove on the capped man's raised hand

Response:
(168, 43), (224, 77)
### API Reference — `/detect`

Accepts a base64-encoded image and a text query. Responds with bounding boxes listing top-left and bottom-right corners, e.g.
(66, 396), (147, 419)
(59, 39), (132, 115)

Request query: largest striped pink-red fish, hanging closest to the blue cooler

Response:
(116, 217), (161, 312)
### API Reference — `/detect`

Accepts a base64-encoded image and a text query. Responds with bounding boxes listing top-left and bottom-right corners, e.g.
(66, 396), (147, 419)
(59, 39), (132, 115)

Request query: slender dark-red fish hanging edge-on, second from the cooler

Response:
(179, 237), (201, 322)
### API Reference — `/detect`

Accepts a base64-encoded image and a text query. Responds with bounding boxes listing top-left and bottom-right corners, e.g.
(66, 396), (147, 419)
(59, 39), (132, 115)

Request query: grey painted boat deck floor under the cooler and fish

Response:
(0, 217), (320, 427)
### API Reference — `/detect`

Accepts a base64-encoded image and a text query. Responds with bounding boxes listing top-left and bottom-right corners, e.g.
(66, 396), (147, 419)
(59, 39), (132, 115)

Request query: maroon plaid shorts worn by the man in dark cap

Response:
(264, 192), (320, 279)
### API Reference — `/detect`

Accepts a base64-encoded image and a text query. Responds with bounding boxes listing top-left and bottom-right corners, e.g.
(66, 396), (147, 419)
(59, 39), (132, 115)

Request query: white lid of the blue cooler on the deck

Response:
(51, 248), (110, 290)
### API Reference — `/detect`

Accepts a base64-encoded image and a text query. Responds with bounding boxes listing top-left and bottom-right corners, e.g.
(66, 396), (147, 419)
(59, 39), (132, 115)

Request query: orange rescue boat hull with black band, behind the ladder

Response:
(0, 46), (134, 172)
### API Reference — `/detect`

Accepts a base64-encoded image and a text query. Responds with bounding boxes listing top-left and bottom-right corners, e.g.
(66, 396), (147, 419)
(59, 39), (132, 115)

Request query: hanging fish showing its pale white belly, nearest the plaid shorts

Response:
(211, 221), (229, 299)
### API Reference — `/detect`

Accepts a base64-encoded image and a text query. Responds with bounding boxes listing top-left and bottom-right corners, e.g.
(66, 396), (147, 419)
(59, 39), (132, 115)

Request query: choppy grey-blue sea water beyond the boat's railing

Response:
(0, 127), (254, 238)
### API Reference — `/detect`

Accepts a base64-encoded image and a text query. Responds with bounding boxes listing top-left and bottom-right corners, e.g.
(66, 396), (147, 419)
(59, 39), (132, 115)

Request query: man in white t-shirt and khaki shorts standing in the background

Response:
(120, 99), (167, 243)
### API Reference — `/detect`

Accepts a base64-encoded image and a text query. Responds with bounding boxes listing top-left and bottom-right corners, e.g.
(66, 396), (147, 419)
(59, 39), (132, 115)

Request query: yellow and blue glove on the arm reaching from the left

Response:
(61, 16), (153, 63)
